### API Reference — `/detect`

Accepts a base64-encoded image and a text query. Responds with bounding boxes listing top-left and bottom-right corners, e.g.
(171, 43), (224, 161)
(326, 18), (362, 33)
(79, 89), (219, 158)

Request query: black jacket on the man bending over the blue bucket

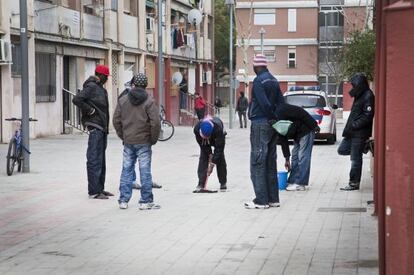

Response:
(277, 104), (318, 158)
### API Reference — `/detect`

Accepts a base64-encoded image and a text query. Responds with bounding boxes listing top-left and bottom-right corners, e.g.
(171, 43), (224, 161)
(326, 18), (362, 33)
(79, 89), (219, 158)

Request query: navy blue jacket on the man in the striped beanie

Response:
(249, 69), (285, 120)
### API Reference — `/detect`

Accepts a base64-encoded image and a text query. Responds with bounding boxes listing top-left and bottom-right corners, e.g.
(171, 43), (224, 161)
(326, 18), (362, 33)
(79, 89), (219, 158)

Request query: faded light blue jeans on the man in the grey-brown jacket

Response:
(119, 144), (154, 203)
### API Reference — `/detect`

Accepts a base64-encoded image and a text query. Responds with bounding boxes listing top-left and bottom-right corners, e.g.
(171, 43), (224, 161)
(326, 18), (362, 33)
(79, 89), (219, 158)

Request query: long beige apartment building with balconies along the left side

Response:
(0, 0), (214, 142)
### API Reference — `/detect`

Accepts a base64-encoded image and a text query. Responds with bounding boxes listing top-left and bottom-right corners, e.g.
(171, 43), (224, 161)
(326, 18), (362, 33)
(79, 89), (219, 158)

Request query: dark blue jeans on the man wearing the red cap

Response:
(86, 129), (107, 195)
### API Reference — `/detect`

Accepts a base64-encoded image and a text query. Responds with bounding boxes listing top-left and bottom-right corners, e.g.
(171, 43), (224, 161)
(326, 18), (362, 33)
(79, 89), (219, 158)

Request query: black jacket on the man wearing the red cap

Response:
(72, 76), (109, 133)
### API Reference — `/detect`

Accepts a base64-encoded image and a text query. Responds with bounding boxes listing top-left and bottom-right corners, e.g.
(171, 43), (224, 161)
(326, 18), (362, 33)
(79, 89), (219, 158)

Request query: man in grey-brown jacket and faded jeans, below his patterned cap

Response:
(113, 87), (161, 210)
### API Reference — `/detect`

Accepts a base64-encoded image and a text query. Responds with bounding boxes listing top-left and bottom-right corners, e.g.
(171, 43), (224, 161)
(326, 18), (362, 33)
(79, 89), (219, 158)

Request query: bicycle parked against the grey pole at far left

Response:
(5, 117), (37, 176)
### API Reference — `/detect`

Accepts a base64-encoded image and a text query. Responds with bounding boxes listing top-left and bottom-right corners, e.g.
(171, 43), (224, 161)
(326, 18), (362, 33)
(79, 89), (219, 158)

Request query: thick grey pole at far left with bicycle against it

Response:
(20, 0), (30, 173)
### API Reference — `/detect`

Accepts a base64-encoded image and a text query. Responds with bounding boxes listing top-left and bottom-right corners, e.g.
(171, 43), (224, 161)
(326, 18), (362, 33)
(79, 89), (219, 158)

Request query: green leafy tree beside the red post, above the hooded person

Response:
(343, 30), (375, 80)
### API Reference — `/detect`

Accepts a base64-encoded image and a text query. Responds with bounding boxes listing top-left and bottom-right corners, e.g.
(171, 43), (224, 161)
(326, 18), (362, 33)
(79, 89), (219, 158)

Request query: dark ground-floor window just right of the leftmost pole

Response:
(35, 53), (56, 102)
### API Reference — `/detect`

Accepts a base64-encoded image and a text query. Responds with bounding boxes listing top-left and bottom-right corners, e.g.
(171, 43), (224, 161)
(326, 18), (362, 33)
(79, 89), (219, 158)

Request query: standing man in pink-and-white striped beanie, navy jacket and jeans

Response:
(245, 54), (284, 209)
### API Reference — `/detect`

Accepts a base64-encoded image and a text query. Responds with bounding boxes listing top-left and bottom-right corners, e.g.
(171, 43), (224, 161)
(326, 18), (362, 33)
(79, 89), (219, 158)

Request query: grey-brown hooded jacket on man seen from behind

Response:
(113, 88), (161, 145)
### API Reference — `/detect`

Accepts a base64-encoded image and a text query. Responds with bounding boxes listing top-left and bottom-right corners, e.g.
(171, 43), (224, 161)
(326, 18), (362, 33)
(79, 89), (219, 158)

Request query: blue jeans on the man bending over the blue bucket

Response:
(288, 132), (315, 185)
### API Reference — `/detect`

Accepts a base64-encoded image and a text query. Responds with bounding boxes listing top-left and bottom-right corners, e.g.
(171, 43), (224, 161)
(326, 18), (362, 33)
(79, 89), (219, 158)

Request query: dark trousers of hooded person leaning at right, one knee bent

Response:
(338, 137), (367, 186)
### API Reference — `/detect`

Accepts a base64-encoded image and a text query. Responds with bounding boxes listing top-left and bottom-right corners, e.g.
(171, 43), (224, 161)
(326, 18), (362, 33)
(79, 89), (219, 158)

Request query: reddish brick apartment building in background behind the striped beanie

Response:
(236, 0), (319, 95)
